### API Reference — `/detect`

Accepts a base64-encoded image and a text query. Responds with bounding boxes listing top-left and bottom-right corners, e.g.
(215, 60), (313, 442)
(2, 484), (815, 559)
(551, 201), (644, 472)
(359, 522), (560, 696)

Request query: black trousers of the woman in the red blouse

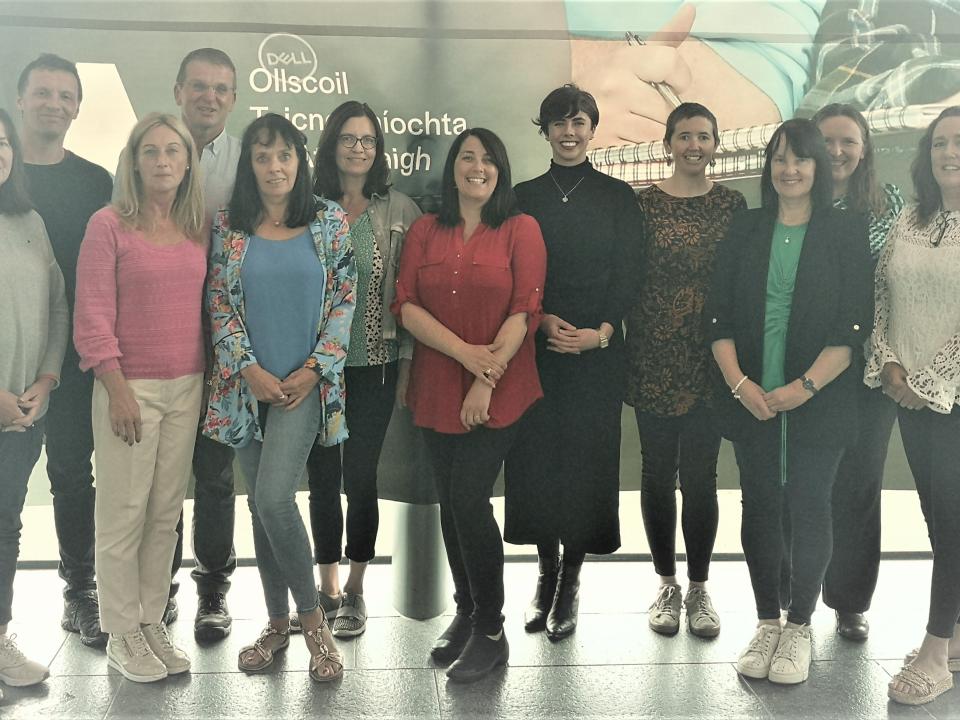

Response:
(423, 423), (517, 635)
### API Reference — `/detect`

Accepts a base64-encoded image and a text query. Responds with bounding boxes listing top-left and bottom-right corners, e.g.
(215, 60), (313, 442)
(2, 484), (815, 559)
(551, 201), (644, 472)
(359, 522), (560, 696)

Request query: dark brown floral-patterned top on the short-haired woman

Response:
(626, 185), (747, 416)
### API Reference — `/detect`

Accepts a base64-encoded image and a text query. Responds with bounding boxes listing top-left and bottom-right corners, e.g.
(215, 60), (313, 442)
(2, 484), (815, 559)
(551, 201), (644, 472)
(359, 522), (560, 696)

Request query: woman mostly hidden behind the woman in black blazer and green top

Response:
(811, 103), (903, 640)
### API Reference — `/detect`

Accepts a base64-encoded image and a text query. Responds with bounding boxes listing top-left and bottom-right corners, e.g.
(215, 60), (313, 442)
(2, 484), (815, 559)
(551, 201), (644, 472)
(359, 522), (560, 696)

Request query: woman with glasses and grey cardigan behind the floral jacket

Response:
(307, 100), (421, 637)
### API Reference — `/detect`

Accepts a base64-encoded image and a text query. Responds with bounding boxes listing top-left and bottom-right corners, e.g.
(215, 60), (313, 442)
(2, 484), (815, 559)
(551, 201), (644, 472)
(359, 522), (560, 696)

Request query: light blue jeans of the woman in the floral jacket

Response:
(237, 390), (323, 618)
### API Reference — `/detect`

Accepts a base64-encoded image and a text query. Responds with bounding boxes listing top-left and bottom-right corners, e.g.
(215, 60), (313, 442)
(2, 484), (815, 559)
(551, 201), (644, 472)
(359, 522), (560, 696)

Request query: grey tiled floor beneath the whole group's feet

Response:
(0, 560), (960, 720)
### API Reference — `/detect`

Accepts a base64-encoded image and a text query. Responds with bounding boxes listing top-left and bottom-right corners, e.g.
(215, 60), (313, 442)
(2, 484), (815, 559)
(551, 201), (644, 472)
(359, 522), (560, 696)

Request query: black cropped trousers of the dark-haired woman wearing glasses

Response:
(307, 362), (397, 564)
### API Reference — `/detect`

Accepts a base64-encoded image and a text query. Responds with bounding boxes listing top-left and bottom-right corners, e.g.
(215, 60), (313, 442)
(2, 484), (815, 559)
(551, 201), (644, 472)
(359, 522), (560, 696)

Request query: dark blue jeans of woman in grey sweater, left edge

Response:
(0, 420), (43, 625)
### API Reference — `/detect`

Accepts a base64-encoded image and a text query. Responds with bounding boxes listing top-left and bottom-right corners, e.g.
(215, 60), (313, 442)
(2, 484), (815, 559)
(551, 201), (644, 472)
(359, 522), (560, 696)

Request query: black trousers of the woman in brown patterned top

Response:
(635, 407), (720, 582)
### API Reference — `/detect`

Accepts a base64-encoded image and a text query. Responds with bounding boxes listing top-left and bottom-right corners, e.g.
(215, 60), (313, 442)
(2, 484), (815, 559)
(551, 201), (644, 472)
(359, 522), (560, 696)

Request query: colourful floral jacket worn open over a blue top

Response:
(203, 200), (357, 447)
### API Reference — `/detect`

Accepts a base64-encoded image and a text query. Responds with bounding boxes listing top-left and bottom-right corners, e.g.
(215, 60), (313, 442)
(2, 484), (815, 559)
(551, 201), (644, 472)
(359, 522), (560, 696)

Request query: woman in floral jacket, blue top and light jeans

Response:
(204, 114), (357, 681)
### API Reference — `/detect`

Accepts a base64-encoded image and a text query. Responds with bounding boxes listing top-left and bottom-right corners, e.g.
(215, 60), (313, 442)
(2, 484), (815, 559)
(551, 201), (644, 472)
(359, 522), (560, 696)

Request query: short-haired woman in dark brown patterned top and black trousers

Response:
(626, 103), (746, 637)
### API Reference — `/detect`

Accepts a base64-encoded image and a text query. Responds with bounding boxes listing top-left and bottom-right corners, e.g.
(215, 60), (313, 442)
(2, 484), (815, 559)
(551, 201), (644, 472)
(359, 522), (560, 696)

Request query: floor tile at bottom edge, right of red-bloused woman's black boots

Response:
(438, 665), (770, 720)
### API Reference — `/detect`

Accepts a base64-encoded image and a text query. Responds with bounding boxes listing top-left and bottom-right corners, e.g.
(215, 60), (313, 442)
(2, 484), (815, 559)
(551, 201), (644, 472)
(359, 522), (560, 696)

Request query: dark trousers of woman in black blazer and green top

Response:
(733, 418), (843, 624)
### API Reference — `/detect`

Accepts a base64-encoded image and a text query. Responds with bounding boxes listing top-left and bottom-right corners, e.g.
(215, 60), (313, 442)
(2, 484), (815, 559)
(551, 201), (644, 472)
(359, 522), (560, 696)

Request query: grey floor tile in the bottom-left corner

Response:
(0, 677), (125, 720)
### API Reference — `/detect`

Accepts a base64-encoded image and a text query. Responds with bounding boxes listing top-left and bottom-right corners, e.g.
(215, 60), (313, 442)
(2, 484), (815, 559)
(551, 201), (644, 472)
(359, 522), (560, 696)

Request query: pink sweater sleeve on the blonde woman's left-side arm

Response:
(73, 215), (123, 376)
